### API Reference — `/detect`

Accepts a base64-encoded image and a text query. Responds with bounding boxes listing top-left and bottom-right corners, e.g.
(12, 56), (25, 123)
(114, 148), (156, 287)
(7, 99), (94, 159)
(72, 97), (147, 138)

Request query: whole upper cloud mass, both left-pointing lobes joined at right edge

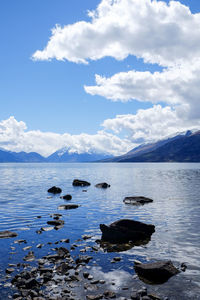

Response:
(33, 0), (200, 119)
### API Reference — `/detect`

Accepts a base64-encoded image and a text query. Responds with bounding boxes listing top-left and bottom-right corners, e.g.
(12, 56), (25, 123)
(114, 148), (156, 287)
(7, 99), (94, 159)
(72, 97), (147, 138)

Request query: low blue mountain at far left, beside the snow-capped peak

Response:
(0, 148), (45, 162)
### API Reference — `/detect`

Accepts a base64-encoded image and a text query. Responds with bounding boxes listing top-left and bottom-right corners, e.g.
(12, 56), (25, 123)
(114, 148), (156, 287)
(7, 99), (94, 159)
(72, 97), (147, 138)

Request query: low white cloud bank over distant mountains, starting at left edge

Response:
(0, 117), (133, 156)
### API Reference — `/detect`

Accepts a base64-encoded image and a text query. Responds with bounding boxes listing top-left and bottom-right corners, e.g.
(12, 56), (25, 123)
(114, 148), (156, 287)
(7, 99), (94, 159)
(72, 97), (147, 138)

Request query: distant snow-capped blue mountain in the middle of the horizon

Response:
(47, 148), (111, 162)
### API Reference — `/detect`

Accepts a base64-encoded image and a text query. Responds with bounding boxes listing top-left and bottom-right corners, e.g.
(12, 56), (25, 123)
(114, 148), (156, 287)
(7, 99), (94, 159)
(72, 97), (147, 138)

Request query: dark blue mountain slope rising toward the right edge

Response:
(103, 131), (200, 162)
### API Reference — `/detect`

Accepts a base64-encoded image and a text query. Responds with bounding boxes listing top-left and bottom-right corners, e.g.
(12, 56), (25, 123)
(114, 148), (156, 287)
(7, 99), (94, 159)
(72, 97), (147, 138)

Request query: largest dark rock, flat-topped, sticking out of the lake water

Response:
(100, 219), (155, 243)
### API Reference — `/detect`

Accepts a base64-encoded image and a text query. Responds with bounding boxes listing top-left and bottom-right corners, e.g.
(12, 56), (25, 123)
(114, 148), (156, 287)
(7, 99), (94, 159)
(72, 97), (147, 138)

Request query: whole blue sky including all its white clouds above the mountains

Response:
(0, 0), (200, 156)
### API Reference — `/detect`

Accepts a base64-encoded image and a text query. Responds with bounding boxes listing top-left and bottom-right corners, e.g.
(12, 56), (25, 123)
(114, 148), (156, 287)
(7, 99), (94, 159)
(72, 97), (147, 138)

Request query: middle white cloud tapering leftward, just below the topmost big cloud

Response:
(85, 59), (200, 118)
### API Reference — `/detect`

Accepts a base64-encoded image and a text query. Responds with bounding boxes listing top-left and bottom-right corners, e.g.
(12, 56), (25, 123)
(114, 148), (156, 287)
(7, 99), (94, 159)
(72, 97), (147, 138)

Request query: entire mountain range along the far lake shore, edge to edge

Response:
(0, 130), (200, 163)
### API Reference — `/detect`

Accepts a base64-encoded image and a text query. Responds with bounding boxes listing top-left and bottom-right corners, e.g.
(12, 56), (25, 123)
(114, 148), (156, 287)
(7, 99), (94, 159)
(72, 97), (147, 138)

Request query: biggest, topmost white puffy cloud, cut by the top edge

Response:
(33, 0), (200, 66)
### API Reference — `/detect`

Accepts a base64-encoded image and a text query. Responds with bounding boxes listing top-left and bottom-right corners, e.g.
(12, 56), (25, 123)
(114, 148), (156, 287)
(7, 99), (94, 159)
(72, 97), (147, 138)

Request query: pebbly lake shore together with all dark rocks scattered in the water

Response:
(0, 179), (186, 300)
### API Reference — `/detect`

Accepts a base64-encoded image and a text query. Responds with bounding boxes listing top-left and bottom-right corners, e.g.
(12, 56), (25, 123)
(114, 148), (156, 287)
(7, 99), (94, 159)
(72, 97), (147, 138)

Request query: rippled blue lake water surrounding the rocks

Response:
(0, 163), (200, 299)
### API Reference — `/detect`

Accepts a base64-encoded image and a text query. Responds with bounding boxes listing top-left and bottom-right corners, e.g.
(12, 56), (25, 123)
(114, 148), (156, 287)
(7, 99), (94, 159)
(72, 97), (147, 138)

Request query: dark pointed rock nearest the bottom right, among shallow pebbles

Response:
(134, 260), (180, 284)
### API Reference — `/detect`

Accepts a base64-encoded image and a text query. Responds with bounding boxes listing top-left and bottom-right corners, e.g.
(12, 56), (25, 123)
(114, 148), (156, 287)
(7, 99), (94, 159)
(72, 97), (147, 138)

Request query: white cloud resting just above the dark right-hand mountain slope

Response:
(102, 105), (200, 144)
